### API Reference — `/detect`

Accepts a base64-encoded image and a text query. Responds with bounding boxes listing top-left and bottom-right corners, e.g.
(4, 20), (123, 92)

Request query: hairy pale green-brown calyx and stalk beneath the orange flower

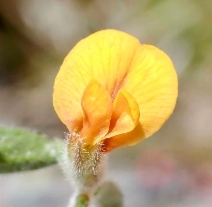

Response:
(62, 132), (106, 207)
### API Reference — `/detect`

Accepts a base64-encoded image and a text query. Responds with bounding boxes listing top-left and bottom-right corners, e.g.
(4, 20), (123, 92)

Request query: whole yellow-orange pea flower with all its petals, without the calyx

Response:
(53, 30), (178, 152)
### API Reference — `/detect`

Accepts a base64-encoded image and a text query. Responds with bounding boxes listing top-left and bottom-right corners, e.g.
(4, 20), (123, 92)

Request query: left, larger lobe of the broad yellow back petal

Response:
(53, 29), (139, 134)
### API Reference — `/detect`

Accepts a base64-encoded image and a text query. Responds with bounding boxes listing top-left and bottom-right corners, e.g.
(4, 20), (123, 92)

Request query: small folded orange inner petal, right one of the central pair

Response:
(105, 89), (140, 138)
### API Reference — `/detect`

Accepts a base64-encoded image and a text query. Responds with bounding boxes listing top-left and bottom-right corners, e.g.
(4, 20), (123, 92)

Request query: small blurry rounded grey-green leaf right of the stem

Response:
(94, 182), (123, 207)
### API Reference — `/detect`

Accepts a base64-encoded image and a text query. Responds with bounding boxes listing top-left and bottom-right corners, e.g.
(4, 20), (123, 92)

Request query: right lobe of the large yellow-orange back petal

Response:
(106, 45), (178, 149)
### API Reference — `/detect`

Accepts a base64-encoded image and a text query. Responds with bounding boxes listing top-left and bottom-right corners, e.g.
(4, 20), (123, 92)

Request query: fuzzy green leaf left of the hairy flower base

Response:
(0, 127), (62, 173)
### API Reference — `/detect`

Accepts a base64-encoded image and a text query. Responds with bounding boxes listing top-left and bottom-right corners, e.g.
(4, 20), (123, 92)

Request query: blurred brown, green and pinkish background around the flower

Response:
(0, 0), (212, 207)
